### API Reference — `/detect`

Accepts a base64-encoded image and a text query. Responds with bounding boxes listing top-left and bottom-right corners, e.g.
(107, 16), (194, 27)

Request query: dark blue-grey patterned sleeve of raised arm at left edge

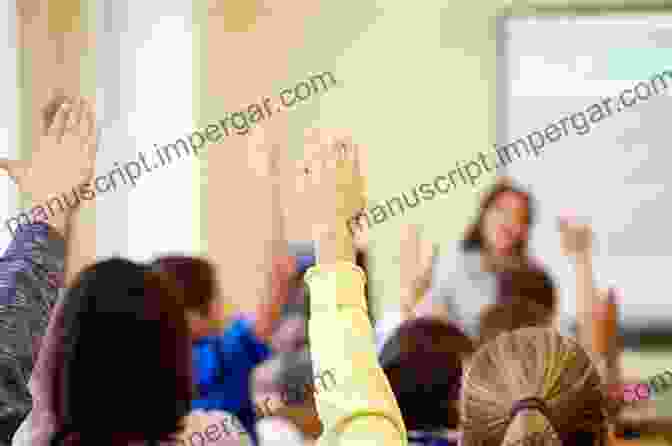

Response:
(0, 223), (65, 446)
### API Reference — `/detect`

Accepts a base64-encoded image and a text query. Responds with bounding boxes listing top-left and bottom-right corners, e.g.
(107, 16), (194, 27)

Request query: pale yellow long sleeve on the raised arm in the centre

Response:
(305, 262), (407, 446)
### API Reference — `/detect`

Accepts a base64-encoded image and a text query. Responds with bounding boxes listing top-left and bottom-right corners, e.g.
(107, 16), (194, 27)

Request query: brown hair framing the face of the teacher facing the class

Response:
(462, 178), (535, 259)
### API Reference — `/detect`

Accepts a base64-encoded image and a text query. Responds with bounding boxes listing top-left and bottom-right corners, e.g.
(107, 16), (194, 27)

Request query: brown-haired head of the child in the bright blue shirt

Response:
(152, 255), (222, 339)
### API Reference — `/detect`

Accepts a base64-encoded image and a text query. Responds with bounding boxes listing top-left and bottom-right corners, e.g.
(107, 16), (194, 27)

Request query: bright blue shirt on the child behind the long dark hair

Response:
(192, 317), (271, 444)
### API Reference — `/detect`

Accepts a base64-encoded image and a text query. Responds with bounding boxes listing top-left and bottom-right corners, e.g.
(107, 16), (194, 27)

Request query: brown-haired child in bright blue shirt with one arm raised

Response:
(152, 255), (296, 442)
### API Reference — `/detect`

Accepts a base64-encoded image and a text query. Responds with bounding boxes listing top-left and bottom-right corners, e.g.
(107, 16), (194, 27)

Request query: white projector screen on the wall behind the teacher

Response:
(497, 16), (672, 330)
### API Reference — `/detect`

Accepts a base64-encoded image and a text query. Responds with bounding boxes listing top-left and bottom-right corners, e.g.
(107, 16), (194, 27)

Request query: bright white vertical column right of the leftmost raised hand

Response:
(97, 0), (199, 260)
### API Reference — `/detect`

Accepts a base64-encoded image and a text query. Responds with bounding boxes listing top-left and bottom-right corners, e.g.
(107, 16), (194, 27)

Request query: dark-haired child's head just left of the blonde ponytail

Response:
(379, 318), (473, 431)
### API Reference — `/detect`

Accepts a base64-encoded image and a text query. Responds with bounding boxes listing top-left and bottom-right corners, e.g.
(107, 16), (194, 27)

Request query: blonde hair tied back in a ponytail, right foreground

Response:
(460, 327), (607, 446)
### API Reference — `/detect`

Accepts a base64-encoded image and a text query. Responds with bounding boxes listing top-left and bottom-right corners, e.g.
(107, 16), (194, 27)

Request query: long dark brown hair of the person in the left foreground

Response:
(51, 259), (193, 445)
